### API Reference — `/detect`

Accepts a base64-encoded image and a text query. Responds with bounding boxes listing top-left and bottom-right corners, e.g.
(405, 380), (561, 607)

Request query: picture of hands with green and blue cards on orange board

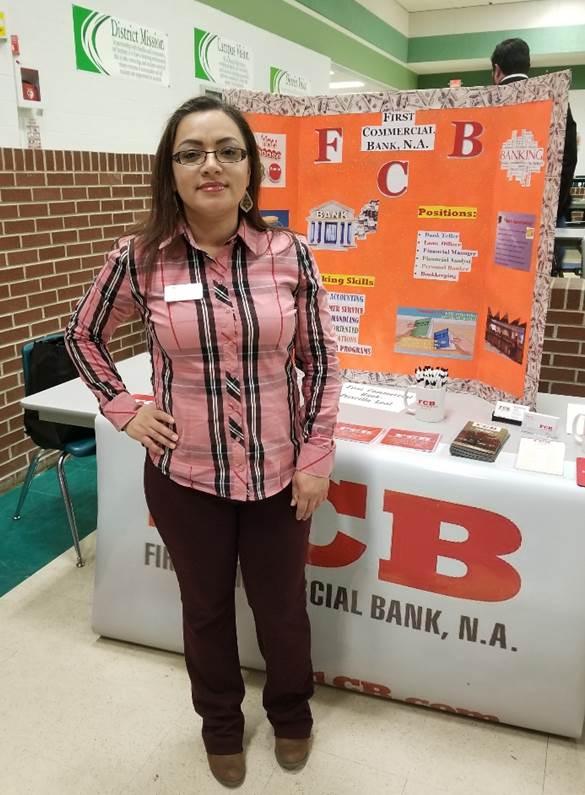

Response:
(394, 306), (477, 359)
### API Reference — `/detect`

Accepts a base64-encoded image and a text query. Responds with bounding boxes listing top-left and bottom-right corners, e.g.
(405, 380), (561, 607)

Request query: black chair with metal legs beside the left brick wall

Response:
(12, 333), (96, 566)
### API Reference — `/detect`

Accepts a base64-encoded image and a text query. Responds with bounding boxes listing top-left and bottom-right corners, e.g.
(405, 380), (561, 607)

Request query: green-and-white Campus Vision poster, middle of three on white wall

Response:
(195, 28), (253, 88)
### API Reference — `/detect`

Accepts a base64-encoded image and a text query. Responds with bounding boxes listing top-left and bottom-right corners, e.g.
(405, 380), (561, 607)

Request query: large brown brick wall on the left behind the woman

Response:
(0, 149), (151, 491)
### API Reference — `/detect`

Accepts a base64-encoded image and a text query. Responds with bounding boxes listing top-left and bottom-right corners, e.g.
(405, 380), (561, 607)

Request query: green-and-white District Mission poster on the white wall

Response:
(72, 5), (170, 86)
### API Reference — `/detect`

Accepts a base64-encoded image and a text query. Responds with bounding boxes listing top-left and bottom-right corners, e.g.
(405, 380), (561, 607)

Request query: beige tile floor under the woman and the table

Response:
(0, 534), (585, 795)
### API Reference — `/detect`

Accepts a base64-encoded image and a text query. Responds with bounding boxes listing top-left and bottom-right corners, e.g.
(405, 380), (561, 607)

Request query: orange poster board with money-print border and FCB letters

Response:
(228, 73), (568, 402)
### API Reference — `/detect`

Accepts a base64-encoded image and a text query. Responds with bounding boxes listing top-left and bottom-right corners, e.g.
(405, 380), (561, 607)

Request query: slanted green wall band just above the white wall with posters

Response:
(203, 0), (416, 88)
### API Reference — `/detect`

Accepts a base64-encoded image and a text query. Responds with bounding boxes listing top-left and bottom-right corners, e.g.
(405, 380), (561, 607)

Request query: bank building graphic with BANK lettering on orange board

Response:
(307, 199), (380, 251)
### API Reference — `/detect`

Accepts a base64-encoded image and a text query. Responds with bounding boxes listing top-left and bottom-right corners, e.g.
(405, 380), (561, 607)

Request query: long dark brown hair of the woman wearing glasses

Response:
(135, 96), (272, 271)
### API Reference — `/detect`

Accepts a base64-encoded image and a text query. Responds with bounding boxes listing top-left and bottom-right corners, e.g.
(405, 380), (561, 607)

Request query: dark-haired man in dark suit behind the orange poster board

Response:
(491, 39), (577, 258)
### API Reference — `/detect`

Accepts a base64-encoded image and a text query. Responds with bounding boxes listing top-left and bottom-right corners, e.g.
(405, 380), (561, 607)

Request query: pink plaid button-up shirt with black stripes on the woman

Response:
(66, 222), (340, 500)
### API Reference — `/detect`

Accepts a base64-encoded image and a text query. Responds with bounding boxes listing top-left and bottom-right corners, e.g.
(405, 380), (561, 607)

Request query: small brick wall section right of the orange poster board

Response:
(538, 277), (585, 397)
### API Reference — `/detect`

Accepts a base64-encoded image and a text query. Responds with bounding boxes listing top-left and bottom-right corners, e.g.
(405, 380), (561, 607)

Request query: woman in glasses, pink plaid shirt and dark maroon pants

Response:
(66, 97), (340, 786)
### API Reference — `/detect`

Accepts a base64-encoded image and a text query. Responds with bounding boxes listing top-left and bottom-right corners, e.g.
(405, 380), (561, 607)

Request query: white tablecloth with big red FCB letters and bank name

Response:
(93, 387), (585, 736)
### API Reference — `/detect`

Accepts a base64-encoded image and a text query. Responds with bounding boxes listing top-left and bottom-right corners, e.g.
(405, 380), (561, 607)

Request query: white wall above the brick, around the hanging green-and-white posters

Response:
(0, 0), (330, 153)
